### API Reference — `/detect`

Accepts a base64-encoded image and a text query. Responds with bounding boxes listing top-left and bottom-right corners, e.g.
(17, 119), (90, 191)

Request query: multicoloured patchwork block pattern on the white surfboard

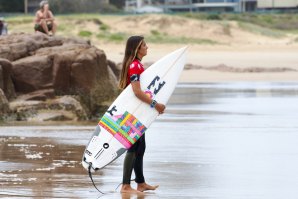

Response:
(99, 111), (147, 149)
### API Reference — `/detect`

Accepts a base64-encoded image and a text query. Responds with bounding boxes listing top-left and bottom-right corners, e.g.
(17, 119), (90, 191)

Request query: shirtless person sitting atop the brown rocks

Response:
(34, 1), (57, 35)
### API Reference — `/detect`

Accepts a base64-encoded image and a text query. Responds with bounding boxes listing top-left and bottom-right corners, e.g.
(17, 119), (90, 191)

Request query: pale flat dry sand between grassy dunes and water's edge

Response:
(99, 43), (298, 82)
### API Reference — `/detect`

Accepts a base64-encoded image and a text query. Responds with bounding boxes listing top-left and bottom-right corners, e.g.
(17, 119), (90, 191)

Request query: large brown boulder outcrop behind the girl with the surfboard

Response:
(0, 33), (119, 121)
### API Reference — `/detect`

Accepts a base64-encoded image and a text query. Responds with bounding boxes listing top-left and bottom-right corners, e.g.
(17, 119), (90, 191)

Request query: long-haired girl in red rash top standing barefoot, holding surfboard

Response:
(119, 36), (165, 193)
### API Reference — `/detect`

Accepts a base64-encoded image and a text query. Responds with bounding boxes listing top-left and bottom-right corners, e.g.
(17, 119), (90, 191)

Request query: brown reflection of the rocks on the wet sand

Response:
(0, 137), (85, 197)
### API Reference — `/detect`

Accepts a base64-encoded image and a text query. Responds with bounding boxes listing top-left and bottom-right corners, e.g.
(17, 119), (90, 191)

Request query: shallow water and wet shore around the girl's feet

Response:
(0, 83), (298, 199)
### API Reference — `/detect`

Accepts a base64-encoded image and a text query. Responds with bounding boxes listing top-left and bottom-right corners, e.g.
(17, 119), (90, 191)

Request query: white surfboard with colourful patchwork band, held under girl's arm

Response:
(82, 47), (187, 171)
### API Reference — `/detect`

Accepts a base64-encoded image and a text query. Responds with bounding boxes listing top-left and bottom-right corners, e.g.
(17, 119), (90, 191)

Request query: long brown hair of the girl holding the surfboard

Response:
(119, 36), (144, 89)
